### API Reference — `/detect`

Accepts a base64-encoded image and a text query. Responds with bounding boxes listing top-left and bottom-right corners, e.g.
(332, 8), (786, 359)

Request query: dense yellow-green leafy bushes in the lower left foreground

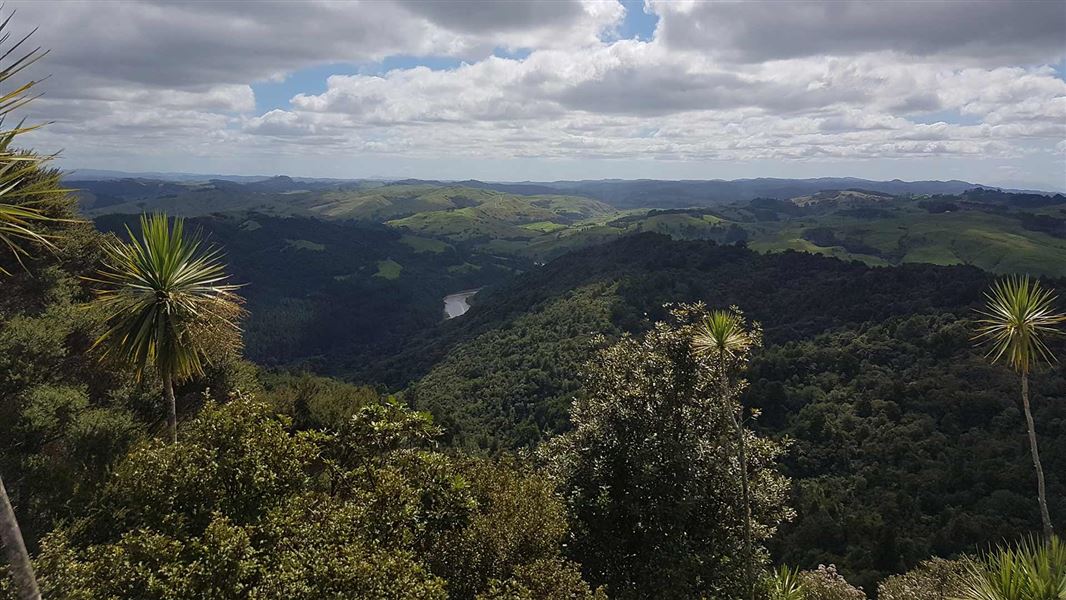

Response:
(31, 392), (602, 600)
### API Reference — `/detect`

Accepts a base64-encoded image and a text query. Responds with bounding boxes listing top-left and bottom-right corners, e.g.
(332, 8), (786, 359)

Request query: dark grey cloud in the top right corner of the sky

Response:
(648, 0), (1066, 64)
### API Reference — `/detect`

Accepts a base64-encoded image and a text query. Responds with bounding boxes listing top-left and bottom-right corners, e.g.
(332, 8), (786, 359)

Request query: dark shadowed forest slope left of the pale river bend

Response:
(95, 213), (527, 374)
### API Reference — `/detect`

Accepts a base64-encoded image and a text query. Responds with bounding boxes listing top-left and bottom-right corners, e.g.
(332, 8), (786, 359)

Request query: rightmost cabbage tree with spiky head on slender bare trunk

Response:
(974, 276), (1066, 539)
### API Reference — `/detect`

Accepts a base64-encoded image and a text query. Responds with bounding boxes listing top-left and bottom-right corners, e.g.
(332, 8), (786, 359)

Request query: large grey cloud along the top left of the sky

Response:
(9, 0), (624, 88)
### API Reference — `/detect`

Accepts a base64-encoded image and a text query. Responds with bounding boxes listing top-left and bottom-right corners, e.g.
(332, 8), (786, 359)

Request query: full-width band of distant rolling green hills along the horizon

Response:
(82, 178), (1066, 276)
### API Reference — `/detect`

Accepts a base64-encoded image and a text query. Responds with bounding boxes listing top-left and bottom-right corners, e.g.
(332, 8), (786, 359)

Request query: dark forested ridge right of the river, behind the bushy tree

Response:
(390, 234), (1066, 589)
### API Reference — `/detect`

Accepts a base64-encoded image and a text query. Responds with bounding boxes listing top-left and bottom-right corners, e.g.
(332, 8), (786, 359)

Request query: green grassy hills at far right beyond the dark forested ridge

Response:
(608, 191), (1066, 277)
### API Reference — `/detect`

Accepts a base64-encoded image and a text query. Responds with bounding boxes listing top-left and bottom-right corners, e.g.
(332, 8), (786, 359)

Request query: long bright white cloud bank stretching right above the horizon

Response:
(251, 45), (1066, 165)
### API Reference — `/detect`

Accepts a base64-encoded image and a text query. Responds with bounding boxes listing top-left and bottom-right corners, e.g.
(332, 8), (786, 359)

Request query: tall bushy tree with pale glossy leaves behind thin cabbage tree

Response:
(544, 305), (790, 598)
